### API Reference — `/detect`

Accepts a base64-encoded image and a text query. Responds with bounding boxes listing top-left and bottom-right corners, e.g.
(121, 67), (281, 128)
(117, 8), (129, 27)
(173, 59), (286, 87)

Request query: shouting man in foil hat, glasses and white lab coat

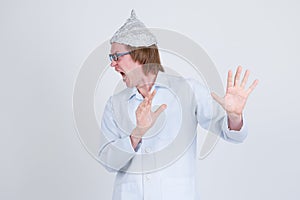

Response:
(99, 11), (258, 200)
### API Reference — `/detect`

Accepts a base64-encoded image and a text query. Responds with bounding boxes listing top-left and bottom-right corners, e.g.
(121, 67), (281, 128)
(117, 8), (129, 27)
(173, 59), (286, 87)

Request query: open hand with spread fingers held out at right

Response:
(211, 66), (258, 130)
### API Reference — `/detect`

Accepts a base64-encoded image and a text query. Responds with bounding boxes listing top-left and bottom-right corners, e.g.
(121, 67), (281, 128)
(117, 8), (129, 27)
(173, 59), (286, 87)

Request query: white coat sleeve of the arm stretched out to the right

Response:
(187, 79), (248, 143)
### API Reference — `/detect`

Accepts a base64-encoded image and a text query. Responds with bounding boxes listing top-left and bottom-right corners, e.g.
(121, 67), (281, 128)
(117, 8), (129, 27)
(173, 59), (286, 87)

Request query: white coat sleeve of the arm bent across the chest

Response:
(98, 98), (140, 172)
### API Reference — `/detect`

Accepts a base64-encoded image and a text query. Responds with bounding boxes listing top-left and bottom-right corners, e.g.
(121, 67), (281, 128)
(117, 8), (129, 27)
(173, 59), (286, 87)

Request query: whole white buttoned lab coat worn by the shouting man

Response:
(99, 73), (247, 200)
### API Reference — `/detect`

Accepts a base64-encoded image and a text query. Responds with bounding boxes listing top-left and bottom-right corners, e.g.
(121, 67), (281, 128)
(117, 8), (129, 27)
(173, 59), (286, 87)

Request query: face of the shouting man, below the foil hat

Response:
(110, 43), (142, 87)
